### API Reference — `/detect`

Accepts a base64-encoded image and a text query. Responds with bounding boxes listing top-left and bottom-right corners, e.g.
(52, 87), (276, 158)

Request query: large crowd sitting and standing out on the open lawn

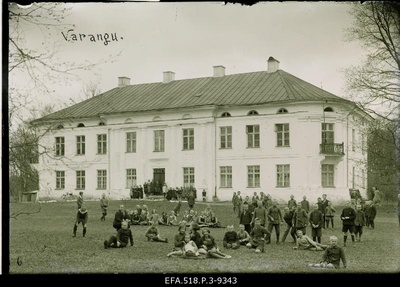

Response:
(73, 191), (388, 268)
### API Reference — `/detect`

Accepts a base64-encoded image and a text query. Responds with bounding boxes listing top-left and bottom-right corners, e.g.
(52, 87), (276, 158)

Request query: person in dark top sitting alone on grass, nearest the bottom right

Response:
(308, 235), (347, 269)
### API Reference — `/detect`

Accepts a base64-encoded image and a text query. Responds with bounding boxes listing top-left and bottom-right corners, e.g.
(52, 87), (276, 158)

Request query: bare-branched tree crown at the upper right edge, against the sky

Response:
(345, 1), (400, 121)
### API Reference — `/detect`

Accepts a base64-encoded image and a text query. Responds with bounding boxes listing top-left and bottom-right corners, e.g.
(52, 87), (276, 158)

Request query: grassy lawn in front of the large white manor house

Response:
(9, 200), (400, 274)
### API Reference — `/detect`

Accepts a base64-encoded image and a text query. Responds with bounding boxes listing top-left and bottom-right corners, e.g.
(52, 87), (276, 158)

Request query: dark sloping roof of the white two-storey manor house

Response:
(34, 70), (347, 122)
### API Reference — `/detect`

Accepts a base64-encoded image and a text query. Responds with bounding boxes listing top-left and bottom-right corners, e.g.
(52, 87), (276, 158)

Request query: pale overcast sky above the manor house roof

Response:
(7, 1), (365, 120)
